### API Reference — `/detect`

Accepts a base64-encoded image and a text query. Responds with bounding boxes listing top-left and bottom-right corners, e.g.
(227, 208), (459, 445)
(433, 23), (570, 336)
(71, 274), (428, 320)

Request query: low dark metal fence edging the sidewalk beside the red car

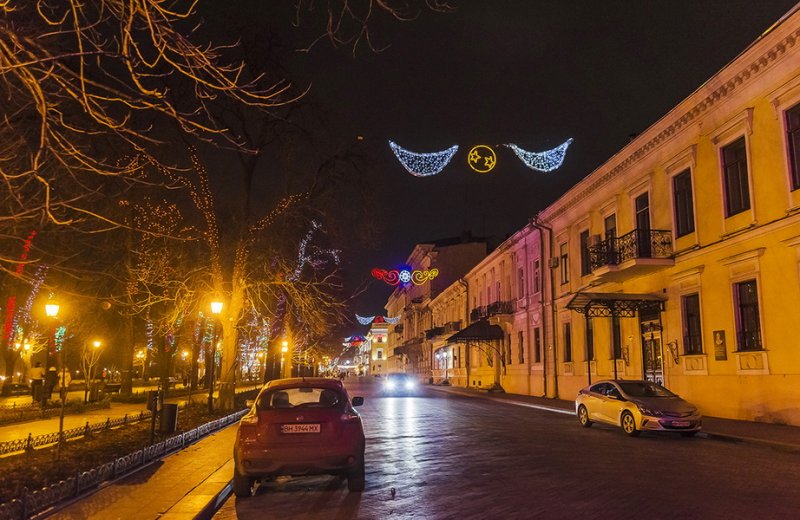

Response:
(0, 410), (247, 520)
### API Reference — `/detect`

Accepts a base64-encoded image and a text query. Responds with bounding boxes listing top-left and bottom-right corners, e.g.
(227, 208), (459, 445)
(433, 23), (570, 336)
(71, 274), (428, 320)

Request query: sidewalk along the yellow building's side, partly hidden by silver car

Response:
(430, 386), (800, 452)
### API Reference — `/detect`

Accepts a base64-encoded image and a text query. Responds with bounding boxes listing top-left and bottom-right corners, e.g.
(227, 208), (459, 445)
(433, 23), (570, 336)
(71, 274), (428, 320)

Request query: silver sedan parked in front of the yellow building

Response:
(575, 379), (703, 437)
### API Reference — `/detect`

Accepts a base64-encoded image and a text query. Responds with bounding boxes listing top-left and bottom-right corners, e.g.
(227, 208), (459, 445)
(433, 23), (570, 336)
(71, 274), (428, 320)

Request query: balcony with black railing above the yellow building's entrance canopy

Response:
(589, 229), (675, 282)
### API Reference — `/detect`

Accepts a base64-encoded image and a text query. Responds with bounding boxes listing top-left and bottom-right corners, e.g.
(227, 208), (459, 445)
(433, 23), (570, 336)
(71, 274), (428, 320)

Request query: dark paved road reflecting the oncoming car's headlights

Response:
(214, 381), (800, 520)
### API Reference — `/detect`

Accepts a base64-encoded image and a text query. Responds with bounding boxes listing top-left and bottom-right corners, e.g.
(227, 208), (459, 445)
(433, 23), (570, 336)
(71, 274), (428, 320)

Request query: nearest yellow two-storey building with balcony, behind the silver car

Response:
(537, 6), (800, 425)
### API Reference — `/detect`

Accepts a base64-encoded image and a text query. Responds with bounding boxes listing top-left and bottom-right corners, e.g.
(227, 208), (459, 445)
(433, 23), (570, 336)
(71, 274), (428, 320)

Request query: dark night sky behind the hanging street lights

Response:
(208, 0), (794, 333)
